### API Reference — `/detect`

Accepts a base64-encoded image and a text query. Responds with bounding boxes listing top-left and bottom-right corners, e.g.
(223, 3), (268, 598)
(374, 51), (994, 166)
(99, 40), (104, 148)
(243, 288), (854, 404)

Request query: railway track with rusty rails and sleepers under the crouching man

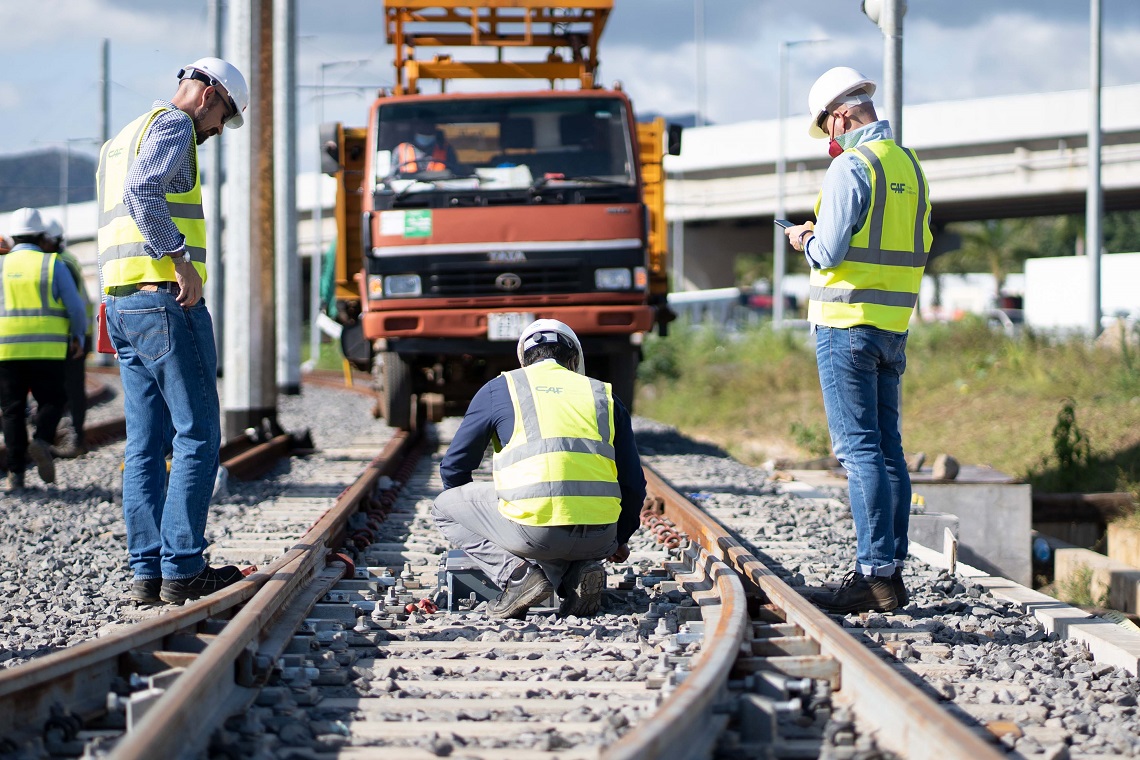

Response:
(0, 407), (1130, 760)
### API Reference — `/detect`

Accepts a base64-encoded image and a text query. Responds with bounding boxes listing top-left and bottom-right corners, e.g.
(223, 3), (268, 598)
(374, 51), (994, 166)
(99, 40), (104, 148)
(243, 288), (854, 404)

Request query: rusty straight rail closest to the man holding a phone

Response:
(645, 466), (1004, 760)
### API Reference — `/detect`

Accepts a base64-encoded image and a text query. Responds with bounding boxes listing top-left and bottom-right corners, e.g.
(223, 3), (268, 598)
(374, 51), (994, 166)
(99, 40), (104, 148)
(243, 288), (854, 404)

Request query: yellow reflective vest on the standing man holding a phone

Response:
(807, 140), (933, 333)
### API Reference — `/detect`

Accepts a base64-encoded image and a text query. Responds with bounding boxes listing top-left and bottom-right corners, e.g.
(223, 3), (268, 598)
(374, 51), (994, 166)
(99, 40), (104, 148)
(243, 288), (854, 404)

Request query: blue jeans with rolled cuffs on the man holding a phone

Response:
(815, 326), (911, 575)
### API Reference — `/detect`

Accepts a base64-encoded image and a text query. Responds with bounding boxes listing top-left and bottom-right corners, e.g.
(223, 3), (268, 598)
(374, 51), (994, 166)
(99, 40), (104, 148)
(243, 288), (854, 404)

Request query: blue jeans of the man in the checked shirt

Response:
(106, 291), (221, 579)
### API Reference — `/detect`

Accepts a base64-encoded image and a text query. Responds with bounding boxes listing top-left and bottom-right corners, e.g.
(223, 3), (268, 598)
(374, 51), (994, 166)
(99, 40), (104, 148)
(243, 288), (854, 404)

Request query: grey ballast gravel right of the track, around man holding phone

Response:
(635, 418), (1140, 758)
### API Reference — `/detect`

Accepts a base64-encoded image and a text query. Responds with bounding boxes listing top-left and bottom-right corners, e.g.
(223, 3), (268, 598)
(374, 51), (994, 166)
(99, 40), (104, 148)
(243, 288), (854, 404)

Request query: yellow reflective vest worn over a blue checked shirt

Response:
(96, 107), (206, 292)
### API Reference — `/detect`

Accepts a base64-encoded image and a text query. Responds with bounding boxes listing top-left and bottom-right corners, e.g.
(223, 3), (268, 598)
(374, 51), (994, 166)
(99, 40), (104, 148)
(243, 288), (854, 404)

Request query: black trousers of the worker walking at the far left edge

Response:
(0, 359), (67, 473)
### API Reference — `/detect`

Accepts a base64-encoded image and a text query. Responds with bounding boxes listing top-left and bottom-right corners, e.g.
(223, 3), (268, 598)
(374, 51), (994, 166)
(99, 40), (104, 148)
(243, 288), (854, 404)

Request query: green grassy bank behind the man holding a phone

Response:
(638, 319), (1140, 495)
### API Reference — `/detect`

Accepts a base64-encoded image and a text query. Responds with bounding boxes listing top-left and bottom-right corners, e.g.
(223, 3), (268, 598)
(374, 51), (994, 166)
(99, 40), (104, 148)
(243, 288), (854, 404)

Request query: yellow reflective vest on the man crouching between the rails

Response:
(491, 360), (621, 525)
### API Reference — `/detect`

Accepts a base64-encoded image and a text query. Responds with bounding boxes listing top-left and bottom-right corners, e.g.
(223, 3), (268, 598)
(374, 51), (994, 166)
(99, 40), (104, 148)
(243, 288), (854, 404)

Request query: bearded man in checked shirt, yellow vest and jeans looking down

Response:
(96, 58), (250, 604)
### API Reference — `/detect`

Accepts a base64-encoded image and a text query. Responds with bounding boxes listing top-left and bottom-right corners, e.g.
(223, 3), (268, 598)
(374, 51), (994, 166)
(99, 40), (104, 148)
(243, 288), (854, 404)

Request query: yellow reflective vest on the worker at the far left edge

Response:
(0, 248), (71, 361)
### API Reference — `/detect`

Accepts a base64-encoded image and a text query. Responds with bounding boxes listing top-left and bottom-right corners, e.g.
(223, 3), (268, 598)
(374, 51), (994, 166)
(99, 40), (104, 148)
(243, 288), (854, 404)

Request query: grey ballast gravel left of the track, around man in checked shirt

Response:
(0, 373), (383, 668)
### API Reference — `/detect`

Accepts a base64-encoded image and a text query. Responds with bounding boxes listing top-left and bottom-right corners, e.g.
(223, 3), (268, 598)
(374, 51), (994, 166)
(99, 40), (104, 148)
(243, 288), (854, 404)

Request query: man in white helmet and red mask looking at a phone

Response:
(787, 66), (931, 614)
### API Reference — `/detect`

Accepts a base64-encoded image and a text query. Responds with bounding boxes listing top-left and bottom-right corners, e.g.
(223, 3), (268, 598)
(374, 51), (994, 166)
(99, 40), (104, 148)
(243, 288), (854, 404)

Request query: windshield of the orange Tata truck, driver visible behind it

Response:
(374, 97), (635, 196)
